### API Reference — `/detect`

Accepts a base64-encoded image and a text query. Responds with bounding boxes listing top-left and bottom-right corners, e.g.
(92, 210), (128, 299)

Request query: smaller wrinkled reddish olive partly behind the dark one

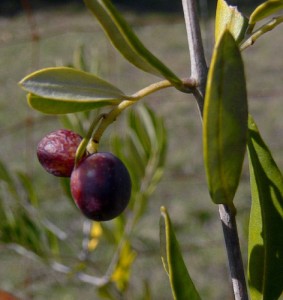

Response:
(37, 129), (82, 177)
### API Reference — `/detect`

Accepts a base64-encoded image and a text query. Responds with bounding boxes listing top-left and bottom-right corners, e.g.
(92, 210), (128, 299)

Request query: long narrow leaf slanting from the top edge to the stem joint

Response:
(84, 0), (182, 87)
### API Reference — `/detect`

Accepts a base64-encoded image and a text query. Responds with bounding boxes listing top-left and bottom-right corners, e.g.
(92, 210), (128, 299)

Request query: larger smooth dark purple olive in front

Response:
(70, 152), (131, 221)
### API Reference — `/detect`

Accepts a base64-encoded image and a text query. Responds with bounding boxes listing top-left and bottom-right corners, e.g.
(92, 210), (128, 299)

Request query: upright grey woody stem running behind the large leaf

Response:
(182, 0), (248, 300)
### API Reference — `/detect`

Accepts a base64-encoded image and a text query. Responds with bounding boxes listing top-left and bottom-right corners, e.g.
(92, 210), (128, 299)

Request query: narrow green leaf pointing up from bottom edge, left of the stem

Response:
(160, 207), (201, 300)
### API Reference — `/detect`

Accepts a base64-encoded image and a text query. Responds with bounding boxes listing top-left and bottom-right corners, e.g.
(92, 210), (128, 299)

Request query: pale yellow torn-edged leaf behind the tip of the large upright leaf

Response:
(215, 0), (248, 42)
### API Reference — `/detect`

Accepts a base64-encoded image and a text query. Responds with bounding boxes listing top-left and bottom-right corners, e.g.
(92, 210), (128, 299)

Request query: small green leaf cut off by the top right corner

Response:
(249, 0), (283, 24)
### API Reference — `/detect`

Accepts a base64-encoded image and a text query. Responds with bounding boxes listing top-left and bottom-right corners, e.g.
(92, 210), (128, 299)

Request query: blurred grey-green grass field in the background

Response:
(0, 1), (283, 300)
